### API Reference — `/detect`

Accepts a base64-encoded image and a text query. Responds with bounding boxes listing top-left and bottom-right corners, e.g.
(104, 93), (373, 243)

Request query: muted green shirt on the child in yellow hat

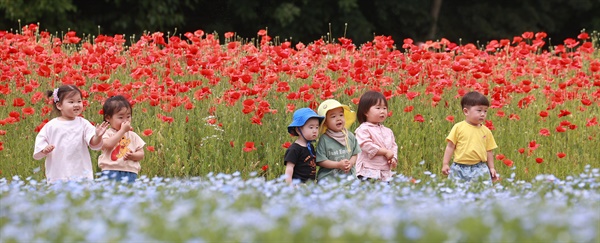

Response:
(317, 132), (360, 181)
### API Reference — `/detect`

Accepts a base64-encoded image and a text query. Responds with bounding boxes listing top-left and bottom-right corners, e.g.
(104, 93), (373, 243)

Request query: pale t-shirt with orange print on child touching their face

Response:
(98, 128), (146, 174)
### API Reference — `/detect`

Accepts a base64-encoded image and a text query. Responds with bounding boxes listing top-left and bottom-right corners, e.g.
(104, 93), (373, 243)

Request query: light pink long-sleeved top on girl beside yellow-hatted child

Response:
(354, 122), (398, 171)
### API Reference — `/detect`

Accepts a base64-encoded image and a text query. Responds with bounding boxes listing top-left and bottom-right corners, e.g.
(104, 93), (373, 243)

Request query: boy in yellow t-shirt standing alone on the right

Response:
(442, 91), (498, 181)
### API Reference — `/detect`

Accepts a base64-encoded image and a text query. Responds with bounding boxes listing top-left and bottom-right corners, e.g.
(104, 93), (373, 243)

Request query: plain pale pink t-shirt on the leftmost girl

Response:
(33, 117), (102, 183)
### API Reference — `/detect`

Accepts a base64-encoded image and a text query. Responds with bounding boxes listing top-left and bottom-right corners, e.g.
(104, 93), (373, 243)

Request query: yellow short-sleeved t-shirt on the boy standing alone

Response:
(446, 121), (498, 165)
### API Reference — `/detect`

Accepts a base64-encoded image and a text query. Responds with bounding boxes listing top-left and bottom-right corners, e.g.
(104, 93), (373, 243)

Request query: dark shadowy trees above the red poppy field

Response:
(0, 0), (600, 43)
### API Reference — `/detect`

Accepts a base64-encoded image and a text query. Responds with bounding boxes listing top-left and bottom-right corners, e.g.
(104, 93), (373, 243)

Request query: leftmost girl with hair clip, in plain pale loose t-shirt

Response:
(33, 85), (108, 183)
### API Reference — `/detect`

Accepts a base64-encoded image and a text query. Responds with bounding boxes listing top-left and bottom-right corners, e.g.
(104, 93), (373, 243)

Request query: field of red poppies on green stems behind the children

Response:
(0, 24), (600, 180)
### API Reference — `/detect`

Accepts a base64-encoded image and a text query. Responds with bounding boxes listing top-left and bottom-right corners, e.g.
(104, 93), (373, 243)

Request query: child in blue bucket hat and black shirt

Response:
(284, 108), (323, 183)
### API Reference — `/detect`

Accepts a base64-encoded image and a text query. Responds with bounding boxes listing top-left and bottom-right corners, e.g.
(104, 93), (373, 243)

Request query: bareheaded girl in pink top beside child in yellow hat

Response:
(355, 91), (398, 181)
